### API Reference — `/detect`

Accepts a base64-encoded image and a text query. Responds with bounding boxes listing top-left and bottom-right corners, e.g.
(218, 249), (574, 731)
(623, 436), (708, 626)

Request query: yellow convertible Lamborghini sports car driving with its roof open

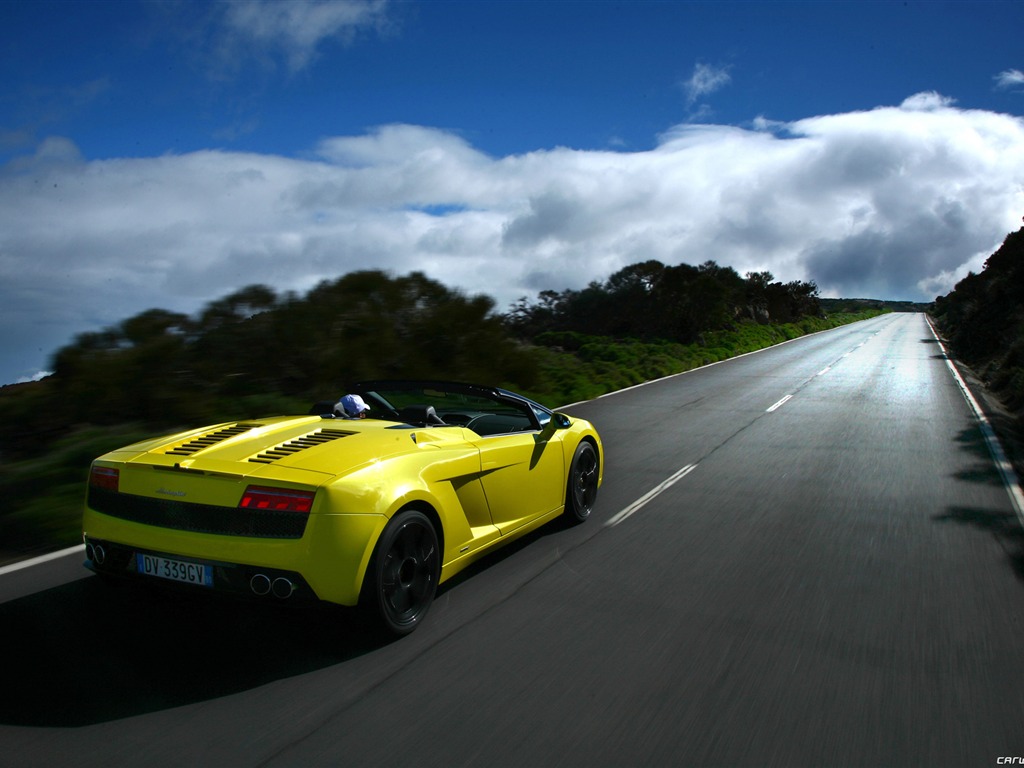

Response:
(88, 381), (604, 635)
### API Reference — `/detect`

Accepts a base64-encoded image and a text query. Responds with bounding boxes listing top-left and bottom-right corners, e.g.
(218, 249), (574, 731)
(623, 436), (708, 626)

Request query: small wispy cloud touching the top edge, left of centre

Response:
(223, 0), (387, 72)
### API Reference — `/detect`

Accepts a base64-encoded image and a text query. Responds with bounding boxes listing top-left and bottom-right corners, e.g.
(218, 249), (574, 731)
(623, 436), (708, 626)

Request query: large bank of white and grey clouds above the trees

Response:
(0, 94), (1024, 381)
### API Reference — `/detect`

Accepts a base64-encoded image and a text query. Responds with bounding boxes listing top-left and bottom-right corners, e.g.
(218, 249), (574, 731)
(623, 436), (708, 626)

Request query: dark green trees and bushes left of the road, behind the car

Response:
(0, 261), (888, 560)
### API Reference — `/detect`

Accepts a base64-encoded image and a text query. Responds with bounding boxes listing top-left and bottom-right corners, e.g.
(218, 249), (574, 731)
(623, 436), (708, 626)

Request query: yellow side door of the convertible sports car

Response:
(468, 427), (565, 536)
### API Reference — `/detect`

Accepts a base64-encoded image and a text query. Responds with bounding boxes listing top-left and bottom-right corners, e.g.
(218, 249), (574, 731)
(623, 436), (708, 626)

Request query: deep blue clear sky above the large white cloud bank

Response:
(9, 0), (1024, 159)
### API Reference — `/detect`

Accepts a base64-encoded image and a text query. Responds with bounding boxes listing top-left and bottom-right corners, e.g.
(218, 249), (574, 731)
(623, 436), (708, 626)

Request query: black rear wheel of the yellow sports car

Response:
(364, 509), (441, 636)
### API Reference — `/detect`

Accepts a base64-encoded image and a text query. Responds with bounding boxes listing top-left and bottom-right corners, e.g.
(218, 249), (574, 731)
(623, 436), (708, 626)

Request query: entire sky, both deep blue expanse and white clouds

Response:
(0, 0), (1024, 383)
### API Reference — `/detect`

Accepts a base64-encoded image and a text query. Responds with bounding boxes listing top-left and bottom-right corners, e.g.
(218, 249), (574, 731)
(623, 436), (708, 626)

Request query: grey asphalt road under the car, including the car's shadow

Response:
(0, 314), (1024, 768)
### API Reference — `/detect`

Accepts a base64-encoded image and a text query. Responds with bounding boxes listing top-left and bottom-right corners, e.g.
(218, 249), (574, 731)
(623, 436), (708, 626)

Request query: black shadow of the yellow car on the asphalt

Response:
(0, 577), (386, 727)
